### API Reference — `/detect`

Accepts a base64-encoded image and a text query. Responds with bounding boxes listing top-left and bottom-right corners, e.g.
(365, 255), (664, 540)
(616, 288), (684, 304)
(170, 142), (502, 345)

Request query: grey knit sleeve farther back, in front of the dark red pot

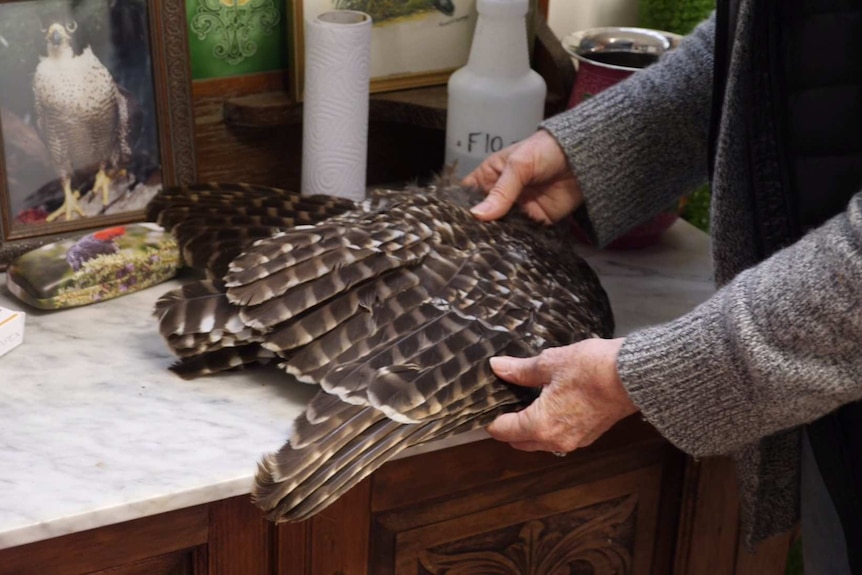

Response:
(541, 17), (715, 245)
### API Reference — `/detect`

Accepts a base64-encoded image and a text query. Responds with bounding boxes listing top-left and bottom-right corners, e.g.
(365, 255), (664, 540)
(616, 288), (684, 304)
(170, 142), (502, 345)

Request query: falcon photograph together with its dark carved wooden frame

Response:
(0, 0), (195, 269)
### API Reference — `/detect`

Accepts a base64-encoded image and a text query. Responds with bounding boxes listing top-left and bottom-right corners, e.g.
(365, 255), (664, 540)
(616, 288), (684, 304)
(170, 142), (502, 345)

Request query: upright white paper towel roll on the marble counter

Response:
(302, 10), (371, 200)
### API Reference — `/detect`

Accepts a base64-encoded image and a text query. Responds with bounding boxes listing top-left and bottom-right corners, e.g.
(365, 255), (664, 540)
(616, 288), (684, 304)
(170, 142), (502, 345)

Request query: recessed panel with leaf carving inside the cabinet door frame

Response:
(402, 466), (661, 575)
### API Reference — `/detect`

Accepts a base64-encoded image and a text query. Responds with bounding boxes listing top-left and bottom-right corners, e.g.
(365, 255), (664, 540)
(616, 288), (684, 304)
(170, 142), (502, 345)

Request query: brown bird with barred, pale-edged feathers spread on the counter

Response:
(148, 183), (613, 521)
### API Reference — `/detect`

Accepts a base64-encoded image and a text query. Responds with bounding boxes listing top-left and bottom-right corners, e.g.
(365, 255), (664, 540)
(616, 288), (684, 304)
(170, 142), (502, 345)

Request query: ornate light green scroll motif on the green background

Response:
(189, 0), (281, 65)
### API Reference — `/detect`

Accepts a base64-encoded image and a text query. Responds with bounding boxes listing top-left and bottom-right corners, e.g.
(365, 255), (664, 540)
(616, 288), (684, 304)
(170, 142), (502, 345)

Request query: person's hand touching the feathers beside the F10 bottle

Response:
(463, 130), (582, 224)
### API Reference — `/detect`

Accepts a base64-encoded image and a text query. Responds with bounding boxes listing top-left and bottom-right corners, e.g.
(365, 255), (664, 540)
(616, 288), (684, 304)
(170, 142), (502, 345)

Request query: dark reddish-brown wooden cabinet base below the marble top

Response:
(0, 417), (789, 575)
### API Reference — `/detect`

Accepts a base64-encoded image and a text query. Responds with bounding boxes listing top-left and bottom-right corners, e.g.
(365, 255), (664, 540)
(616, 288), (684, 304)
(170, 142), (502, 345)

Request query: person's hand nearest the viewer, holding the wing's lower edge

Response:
(487, 338), (638, 453)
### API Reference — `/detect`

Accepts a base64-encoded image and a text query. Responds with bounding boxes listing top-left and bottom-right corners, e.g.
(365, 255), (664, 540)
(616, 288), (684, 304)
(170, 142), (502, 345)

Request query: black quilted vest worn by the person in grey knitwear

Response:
(713, 0), (862, 574)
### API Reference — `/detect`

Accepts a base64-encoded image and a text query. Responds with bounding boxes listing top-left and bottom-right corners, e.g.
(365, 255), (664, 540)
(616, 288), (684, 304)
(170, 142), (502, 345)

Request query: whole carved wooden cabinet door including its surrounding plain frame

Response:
(368, 418), (682, 575)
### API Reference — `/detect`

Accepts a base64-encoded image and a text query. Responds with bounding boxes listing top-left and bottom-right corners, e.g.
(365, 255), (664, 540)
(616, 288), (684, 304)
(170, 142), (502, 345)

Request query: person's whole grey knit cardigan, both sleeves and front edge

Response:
(542, 0), (862, 542)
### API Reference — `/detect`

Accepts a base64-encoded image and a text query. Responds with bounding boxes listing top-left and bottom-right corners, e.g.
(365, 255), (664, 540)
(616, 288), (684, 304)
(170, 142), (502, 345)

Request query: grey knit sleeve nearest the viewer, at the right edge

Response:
(617, 192), (862, 456)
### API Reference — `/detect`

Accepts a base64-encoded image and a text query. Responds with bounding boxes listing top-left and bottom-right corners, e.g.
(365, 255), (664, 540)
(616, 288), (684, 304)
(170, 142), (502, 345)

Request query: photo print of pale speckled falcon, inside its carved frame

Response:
(0, 0), (162, 232)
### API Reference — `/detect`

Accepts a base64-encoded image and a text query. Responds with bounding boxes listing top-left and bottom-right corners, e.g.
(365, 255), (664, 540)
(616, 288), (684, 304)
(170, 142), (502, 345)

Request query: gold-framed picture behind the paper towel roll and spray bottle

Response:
(291, 0), (476, 100)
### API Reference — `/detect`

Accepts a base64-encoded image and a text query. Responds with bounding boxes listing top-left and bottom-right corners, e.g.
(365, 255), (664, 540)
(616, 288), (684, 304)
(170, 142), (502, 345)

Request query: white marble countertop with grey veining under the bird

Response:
(0, 222), (712, 548)
